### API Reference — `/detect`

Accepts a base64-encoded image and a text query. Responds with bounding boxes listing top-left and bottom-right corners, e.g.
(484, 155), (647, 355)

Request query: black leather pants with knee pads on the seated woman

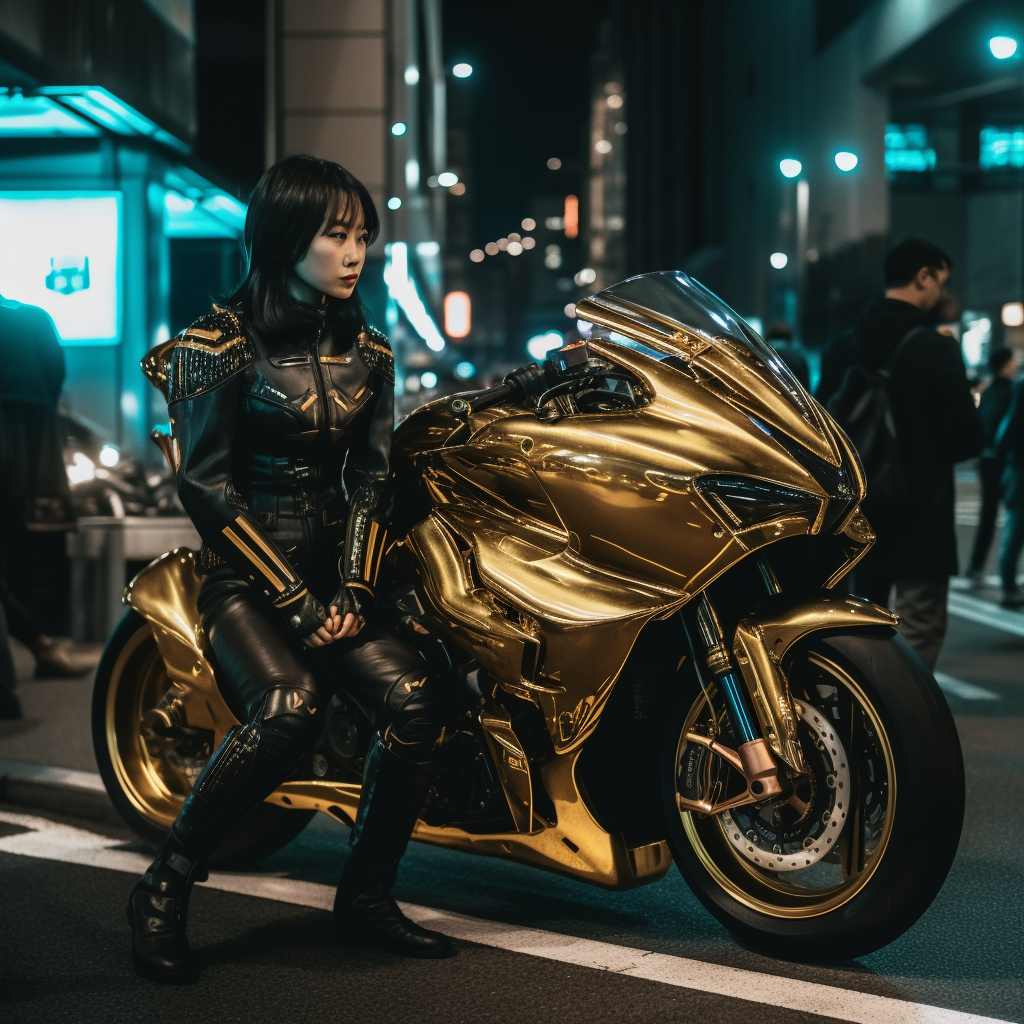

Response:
(172, 570), (449, 860)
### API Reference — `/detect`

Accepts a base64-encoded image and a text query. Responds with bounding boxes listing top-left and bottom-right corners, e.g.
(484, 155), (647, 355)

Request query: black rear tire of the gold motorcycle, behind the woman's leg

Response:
(92, 609), (316, 867)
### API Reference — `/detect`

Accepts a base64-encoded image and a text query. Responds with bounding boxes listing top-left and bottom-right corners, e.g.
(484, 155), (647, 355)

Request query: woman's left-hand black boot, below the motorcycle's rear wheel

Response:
(128, 835), (208, 982)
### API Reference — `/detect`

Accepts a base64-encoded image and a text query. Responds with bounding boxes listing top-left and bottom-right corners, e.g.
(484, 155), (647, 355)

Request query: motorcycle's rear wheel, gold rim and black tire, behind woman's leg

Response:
(92, 610), (315, 867)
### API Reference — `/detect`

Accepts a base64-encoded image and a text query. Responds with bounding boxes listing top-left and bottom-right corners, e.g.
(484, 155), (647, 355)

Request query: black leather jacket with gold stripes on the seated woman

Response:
(168, 309), (394, 637)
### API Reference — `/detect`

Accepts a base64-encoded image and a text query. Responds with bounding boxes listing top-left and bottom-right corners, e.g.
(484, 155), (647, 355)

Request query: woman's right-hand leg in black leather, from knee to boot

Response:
(315, 627), (453, 957)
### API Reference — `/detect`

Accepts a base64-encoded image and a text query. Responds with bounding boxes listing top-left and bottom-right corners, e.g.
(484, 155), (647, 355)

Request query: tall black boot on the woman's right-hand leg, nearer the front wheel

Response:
(334, 739), (455, 959)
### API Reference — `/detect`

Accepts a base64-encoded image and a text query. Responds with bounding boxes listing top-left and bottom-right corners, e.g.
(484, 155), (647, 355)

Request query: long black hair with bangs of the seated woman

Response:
(225, 155), (380, 341)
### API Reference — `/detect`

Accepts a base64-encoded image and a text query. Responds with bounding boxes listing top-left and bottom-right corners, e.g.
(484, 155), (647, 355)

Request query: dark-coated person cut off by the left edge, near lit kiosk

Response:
(0, 296), (95, 718)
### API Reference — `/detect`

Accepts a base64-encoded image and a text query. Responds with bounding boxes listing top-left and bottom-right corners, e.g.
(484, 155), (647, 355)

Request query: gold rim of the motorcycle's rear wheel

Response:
(105, 624), (190, 828)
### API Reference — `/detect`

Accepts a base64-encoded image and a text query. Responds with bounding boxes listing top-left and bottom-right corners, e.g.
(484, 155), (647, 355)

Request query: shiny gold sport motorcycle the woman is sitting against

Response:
(93, 272), (965, 962)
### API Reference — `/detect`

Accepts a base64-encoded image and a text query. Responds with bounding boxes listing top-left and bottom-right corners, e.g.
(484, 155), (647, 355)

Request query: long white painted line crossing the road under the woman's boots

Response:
(0, 811), (1008, 1024)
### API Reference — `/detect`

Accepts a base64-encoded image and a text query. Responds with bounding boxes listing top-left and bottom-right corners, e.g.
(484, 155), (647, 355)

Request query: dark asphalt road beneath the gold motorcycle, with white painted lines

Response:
(0, 598), (1024, 1024)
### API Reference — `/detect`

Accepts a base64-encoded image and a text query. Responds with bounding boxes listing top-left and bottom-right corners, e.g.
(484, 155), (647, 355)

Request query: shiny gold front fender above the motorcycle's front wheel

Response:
(732, 594), (899, 772)
